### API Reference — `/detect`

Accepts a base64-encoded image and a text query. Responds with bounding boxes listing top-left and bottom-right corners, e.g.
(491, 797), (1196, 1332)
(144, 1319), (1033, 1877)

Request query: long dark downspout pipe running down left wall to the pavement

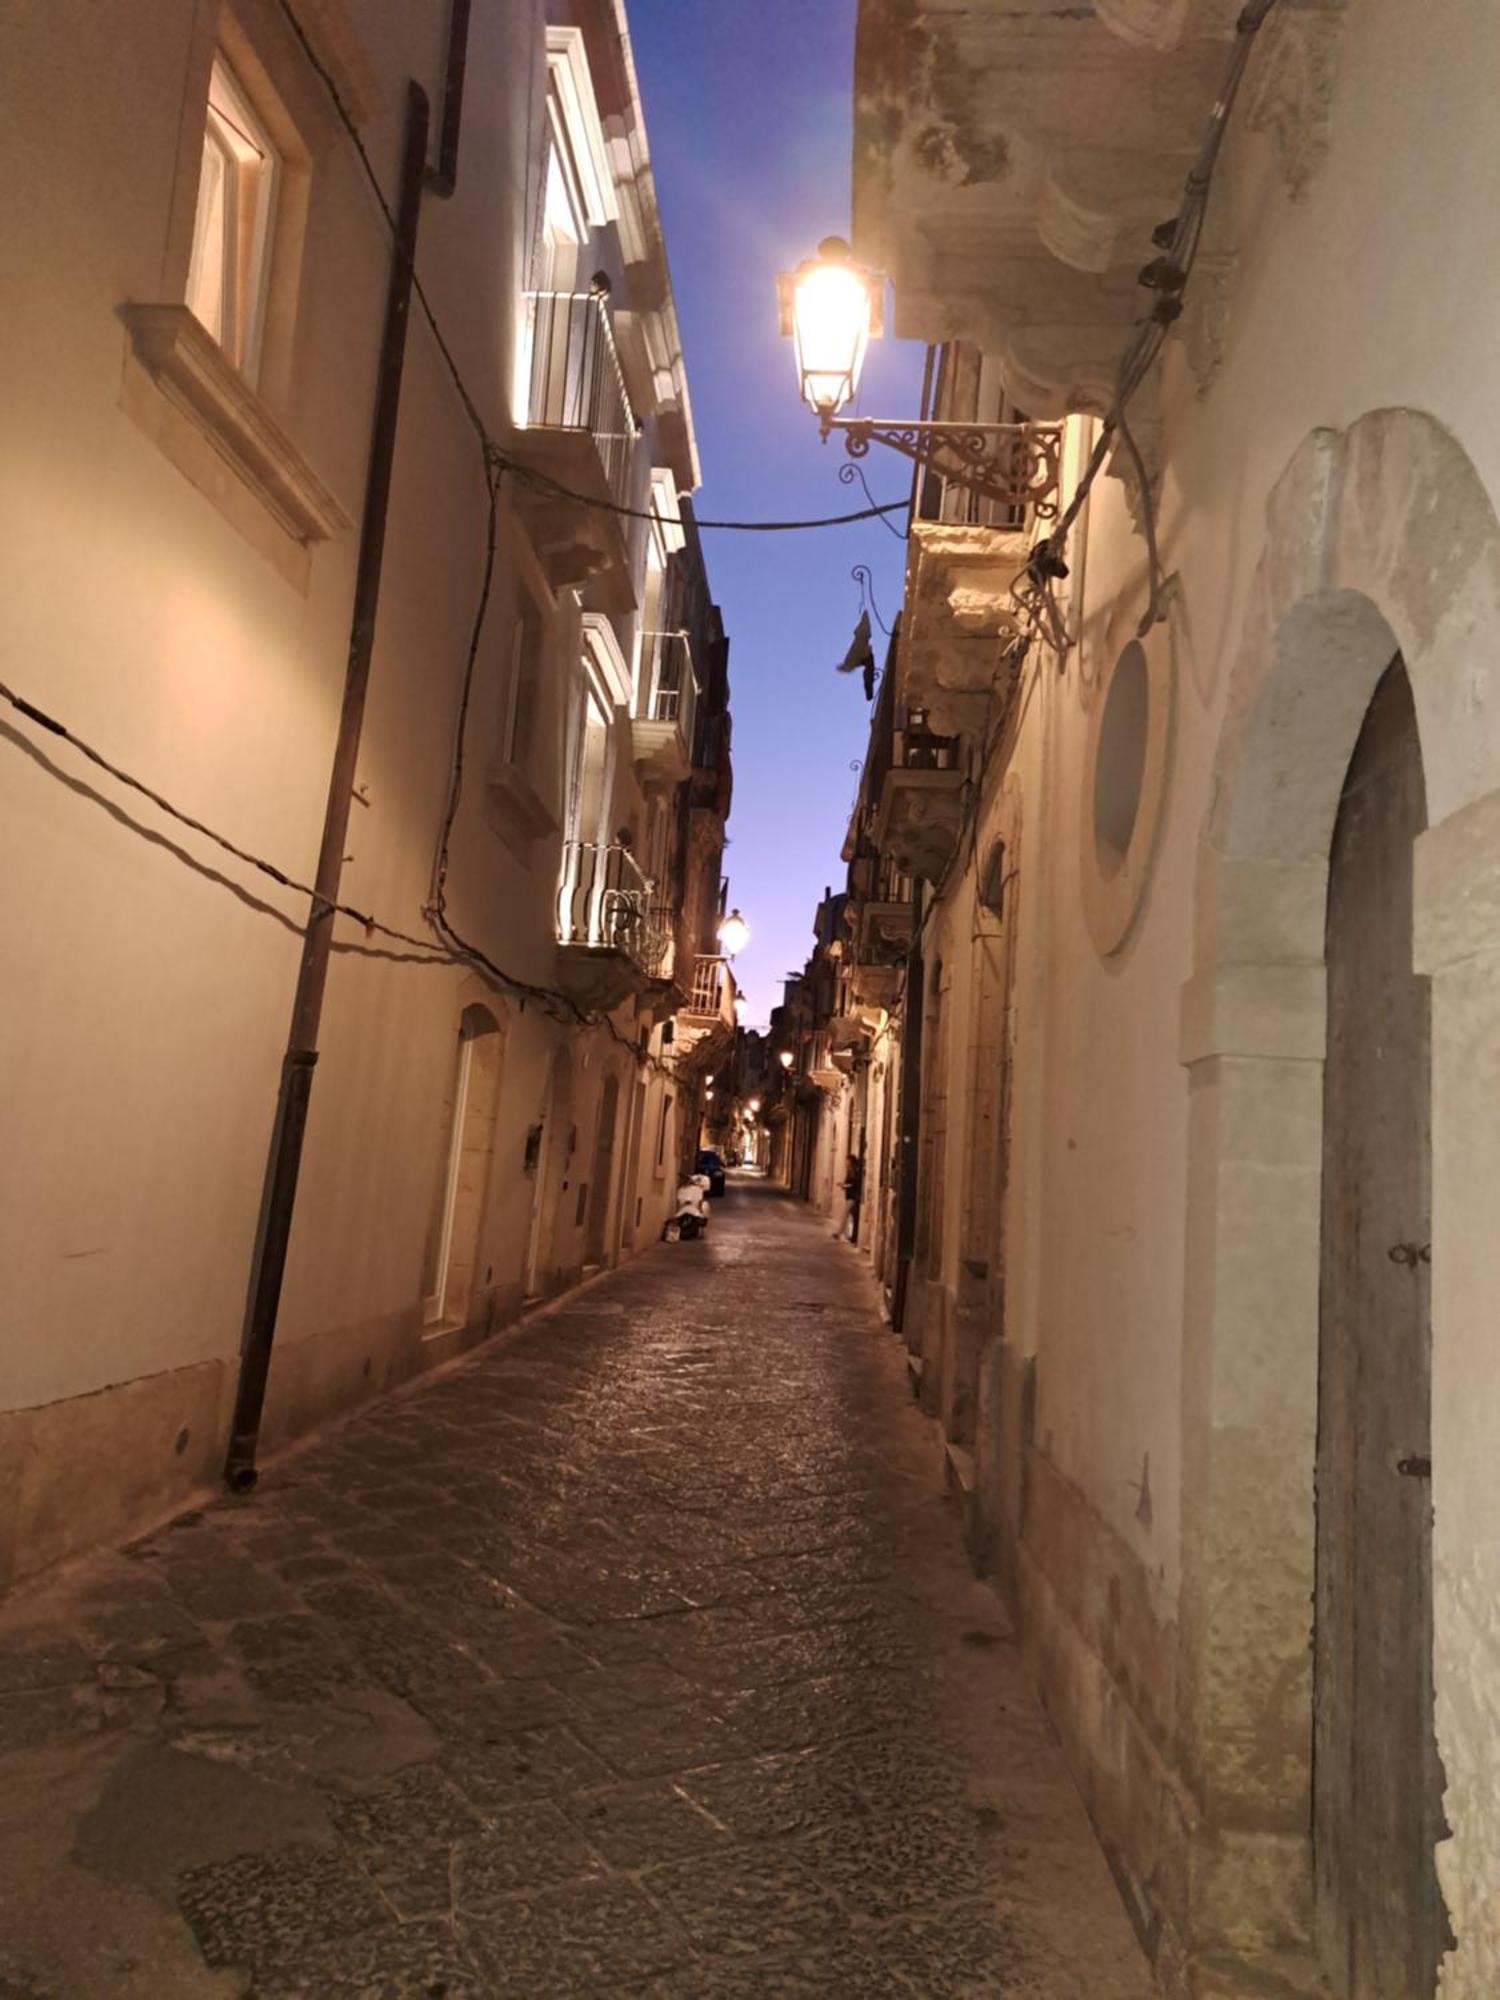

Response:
(224, 80), (428, 1492)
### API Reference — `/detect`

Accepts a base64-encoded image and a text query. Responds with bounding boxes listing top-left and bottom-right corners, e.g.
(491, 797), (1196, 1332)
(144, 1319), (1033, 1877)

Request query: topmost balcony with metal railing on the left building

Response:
(510, 292), (640, 612)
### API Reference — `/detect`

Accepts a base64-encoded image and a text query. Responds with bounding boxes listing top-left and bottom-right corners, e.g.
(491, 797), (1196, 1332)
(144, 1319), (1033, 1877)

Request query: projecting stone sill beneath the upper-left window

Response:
(120, 304), (350, 548)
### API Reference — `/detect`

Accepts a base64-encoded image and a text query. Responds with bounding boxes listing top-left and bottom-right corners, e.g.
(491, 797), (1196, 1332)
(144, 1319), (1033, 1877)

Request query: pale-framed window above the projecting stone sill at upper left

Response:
(188, 56), (280, 380)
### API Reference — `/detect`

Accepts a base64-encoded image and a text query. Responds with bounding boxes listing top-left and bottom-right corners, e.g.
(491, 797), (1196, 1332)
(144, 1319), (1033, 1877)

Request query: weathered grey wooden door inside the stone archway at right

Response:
(1314, 658), (1446, 2000)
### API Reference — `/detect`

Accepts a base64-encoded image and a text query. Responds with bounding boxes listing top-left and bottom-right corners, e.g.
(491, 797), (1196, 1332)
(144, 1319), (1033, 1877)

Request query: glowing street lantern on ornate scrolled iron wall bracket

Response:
(776, 236), (1062, 520)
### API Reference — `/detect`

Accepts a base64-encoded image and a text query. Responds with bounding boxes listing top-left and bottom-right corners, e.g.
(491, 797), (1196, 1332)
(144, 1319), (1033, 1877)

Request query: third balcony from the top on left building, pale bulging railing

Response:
(558, 840), (672, 1012)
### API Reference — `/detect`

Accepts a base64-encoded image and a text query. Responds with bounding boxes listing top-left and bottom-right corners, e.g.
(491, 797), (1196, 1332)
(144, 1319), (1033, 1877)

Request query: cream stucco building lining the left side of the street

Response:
(0, 0), (734, 1586)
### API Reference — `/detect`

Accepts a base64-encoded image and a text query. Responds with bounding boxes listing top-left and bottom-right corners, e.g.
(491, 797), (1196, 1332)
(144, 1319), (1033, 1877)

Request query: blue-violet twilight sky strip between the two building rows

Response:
(630, 0), (922, 1026)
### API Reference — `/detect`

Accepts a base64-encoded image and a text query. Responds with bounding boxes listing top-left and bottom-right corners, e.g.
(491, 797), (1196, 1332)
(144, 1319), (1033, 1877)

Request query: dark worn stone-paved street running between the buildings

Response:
(0, 1184), (1150, 2000)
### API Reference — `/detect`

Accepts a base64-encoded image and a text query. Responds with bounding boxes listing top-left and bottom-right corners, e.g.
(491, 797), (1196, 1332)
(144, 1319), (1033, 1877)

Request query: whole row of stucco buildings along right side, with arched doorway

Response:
(780, 0), (1500, 2000)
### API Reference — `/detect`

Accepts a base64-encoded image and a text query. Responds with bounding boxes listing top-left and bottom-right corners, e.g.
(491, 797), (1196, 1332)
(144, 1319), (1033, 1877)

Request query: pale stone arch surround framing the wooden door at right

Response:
(1178, 410), (1500, 1996)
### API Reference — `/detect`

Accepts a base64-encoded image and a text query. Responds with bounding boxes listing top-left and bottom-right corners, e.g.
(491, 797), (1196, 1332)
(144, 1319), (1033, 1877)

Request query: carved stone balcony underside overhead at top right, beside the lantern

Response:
(854, 0), (1344, 418)
